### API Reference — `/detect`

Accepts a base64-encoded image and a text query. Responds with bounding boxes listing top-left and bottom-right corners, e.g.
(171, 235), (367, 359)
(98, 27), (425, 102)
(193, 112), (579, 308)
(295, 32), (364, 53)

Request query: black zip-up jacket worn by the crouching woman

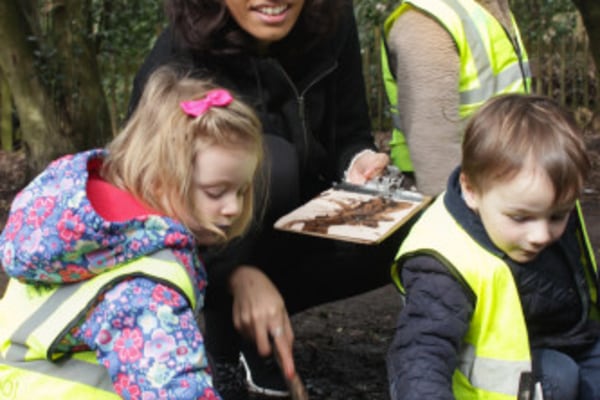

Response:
(129, 2), (374, 283)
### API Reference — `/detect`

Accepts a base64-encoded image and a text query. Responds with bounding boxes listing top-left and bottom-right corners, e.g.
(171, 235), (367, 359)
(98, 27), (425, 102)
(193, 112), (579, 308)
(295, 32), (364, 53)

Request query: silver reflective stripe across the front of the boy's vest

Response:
(458, 343), (531, 396)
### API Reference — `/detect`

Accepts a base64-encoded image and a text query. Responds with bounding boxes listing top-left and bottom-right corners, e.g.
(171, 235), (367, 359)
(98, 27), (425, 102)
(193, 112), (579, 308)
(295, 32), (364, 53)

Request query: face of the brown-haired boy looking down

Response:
(460, 162), (574, 263)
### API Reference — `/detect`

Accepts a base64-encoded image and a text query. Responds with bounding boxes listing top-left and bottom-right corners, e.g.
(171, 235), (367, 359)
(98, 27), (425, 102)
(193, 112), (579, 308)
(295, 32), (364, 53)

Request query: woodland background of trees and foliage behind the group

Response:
(0, 0), (600, 177)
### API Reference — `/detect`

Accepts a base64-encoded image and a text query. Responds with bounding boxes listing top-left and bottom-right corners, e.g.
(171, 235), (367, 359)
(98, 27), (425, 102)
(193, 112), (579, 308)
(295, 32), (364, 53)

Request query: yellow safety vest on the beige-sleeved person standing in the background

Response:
(381, 0), (531, 171)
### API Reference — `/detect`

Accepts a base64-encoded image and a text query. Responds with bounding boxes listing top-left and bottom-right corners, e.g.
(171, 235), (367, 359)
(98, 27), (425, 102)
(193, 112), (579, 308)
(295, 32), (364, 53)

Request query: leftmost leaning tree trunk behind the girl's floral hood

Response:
(0, 0), (74, 172)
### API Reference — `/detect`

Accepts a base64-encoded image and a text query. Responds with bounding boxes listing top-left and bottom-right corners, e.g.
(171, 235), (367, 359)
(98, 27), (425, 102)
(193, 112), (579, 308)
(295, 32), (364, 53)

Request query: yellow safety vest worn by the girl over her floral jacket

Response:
(0, 250), (196, 400)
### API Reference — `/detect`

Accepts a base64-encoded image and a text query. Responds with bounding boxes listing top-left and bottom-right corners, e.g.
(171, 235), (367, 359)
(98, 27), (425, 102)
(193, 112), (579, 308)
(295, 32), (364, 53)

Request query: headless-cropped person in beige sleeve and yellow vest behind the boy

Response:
(381, 0), (531, 195)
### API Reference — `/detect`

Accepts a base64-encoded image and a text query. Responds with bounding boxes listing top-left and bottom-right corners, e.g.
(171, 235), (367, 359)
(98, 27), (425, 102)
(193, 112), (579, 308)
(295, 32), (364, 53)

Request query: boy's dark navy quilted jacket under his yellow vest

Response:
(387, 170), (599, 400)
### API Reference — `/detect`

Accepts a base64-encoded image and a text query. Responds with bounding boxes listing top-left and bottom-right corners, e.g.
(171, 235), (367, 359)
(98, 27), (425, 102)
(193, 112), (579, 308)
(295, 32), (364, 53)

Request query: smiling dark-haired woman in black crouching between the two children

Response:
(131, 0), (402, 395)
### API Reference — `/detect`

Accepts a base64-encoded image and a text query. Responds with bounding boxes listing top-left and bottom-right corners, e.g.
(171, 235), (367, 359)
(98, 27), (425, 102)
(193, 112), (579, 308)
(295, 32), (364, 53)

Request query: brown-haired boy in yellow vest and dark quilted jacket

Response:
(387, 94), (600, 400)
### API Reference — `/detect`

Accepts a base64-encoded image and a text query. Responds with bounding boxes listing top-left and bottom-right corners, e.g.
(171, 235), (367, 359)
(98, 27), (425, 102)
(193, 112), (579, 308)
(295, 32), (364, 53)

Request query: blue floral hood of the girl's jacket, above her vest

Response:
(0, 149), (206, 290)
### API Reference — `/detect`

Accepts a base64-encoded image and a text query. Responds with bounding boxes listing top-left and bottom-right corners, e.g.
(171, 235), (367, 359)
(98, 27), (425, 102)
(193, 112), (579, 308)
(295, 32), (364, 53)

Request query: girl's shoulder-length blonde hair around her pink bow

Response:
(102, 67), (263, 244)
